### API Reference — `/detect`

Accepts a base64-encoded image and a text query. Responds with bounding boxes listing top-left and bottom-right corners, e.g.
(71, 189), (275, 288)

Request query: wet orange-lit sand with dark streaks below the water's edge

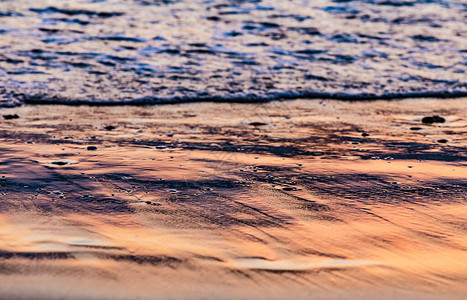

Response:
(0, 99), (467, 299)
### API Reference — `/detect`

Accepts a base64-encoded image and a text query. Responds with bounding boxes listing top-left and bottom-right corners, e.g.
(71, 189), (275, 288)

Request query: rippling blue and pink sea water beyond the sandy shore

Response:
(0, 0), (467, 106)
